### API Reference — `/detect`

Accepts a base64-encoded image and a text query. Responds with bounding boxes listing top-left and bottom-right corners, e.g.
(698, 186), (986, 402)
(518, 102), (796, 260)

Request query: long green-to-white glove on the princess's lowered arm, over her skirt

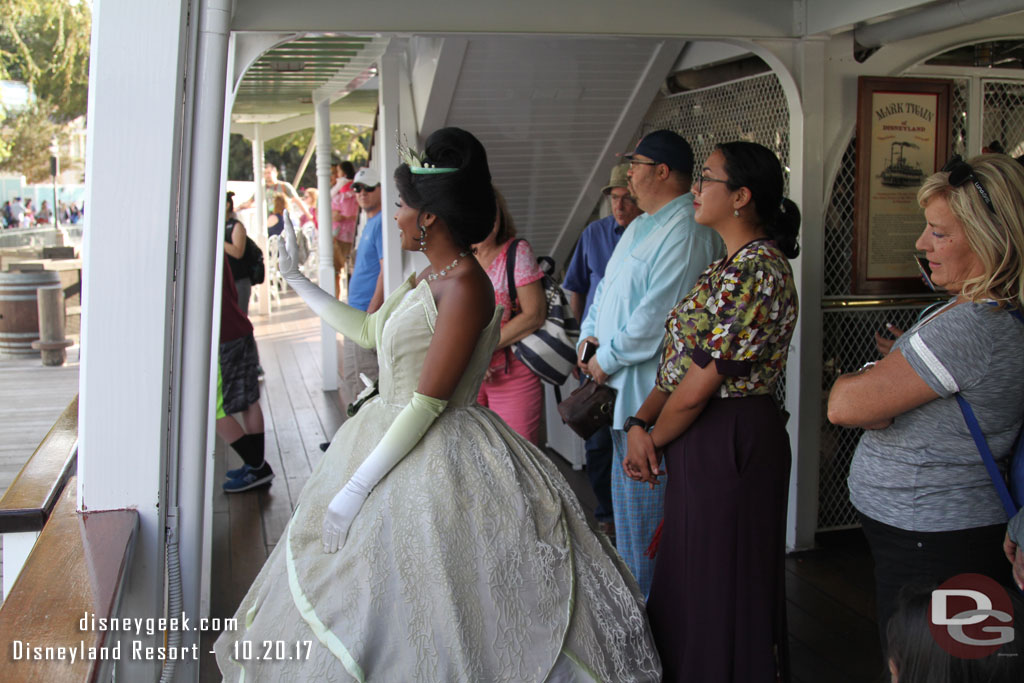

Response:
(321, 392), (447, 553)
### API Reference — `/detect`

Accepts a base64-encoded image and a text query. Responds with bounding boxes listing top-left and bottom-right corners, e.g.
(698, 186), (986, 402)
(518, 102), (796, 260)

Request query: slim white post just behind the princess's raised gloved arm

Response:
(314, 98), (338, 393)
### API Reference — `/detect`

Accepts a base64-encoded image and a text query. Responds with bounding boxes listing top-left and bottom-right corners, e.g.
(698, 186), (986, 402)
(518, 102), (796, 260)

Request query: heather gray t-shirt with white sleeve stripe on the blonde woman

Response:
(848, 303), (1024, 531)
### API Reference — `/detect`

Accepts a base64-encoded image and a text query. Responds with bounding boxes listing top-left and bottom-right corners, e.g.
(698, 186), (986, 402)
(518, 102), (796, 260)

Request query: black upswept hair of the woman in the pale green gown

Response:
(394, 128), (496, 249)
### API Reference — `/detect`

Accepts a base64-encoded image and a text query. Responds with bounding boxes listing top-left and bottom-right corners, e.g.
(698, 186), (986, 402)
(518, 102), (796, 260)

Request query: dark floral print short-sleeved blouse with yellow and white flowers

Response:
(656, 240), (798, 398)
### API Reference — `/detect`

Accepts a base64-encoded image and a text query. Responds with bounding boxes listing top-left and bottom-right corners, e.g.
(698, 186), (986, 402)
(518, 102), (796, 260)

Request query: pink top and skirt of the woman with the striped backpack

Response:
(477, 240), (544, 444)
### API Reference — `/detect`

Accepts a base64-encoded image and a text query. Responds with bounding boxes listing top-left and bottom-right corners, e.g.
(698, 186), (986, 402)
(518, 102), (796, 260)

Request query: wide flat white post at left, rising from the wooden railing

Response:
(78, 0), (192, 681)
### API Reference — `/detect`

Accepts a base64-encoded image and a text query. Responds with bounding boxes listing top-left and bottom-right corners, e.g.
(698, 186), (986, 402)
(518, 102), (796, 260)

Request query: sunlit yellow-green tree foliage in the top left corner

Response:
(0, 0), (92, 123)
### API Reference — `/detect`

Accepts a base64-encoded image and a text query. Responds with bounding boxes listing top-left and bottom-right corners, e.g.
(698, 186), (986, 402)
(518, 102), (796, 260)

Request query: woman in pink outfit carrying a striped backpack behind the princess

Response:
(473, 189), (548, 444)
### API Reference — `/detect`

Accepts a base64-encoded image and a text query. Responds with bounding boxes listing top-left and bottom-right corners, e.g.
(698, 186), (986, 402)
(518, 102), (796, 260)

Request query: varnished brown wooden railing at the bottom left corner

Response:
(0, 397), (138, 682)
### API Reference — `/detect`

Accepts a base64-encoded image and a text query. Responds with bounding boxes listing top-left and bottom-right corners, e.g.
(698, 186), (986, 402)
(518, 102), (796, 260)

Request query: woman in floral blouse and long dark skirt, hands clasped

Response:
(624, 142), (800, 683)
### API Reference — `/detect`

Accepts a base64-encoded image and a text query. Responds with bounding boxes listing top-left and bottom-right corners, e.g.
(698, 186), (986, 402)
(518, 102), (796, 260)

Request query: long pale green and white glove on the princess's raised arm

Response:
(278, 218), (411, 348)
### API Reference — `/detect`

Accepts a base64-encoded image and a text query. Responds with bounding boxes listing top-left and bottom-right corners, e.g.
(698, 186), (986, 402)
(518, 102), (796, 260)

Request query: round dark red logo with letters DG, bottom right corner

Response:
(928, 573), (1014, 659)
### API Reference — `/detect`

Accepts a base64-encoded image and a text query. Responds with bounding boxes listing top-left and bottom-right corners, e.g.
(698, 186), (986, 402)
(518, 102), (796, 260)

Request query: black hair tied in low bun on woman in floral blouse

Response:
(715, 140), (800, 258)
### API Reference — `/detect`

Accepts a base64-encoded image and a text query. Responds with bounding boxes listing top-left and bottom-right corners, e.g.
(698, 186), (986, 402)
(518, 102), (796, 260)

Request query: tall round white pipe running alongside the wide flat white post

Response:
(173, 0), (231, 681)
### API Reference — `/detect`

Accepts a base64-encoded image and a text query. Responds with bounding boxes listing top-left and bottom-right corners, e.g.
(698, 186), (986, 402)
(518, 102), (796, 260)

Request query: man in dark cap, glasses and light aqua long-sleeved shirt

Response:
(577, 130), (724, 595)
